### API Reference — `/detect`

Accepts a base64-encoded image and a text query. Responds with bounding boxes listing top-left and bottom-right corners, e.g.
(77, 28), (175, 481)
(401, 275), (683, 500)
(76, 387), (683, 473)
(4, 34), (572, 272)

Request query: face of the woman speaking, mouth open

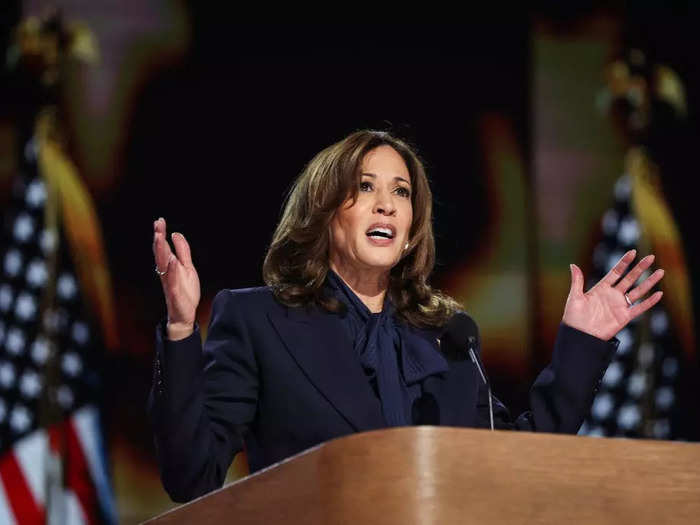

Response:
(330, 145), (413, 271)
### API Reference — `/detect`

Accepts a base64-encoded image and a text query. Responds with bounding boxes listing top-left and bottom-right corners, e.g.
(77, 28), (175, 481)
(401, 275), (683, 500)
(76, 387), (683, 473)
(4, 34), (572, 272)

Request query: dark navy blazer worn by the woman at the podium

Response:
(149, 288), (615, 501)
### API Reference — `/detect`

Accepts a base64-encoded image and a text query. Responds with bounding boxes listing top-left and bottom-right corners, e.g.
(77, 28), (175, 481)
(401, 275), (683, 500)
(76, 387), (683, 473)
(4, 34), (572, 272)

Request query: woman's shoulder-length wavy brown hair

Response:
(263, 130), (461, 327)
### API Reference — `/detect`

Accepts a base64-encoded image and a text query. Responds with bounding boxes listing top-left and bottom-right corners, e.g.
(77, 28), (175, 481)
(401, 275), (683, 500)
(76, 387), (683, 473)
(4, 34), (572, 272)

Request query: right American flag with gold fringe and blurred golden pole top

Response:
(579, 48), (697, 439)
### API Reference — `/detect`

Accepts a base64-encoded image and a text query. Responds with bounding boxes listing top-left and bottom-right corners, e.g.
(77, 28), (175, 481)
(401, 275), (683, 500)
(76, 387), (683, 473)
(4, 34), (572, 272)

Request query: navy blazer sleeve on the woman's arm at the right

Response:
(477, 323), (618, 434)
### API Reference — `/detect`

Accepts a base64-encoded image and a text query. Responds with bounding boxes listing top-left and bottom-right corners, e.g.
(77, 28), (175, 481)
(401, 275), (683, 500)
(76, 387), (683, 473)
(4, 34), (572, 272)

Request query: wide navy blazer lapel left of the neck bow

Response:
(268, 308), (386, 432)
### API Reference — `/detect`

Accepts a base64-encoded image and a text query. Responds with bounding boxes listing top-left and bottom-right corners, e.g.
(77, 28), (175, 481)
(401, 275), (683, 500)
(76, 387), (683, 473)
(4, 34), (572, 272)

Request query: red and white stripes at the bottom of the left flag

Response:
(0, 407), (106, 525)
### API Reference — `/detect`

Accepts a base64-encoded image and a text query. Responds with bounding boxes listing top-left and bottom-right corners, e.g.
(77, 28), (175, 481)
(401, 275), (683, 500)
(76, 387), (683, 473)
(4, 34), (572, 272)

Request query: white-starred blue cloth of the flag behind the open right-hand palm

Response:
(579, 173), (682, 439)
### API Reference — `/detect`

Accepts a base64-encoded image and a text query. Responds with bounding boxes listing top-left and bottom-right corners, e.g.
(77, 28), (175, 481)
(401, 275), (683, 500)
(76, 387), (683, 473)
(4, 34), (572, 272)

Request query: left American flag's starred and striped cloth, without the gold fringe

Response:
(0, 132), (116, 524)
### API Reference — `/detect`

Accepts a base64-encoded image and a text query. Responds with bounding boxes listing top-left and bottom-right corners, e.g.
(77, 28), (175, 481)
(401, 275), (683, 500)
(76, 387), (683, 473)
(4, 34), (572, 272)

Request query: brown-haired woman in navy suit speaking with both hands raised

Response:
(150, 131), (663, 501)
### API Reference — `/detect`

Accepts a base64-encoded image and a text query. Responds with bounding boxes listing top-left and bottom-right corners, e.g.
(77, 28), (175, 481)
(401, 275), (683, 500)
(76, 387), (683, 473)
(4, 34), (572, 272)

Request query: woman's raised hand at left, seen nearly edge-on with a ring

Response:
(153, 217), (200, 340)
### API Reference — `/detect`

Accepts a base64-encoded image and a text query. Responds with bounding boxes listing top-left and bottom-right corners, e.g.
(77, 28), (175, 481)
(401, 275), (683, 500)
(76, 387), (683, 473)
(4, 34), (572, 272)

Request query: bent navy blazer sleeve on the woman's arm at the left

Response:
(148, 291), (258, 502)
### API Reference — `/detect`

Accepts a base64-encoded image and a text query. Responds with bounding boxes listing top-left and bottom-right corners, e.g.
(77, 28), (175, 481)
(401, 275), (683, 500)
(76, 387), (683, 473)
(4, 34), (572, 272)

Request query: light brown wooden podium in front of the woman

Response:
(148, 427), (700, 525)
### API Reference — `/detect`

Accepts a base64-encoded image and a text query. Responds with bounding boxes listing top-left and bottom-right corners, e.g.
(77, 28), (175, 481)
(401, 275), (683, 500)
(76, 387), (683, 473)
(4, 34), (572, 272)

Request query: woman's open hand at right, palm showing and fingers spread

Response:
(562, 250), (664, 341)
